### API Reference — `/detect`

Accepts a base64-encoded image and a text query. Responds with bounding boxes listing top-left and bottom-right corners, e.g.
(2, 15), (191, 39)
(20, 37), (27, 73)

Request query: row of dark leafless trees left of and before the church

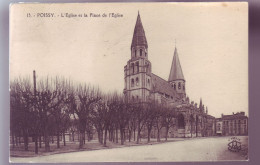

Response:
(10, 73), (176, 153)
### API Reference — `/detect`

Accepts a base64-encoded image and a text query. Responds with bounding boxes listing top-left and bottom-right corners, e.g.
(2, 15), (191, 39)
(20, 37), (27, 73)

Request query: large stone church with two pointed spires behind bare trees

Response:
(124, 12), (215, 137)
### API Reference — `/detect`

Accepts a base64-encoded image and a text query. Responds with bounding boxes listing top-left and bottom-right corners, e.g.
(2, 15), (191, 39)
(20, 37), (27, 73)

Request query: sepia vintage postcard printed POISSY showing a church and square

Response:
(9, 2), (249, 163)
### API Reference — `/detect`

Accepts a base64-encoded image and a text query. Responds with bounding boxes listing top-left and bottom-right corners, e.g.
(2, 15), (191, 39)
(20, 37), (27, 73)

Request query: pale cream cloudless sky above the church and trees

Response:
(10, 2), (248, 117)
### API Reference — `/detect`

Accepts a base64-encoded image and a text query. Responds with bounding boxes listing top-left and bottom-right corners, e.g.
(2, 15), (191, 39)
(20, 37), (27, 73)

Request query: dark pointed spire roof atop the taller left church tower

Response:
(131, 12), (148, 48)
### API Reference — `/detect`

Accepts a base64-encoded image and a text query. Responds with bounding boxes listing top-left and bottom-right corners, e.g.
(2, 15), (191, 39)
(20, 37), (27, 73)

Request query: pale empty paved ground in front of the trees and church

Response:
(11, 137), (247, 163)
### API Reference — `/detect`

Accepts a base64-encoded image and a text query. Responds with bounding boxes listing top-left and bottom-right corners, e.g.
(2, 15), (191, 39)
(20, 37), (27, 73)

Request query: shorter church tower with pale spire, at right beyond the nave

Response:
(168, 47), (186, 98)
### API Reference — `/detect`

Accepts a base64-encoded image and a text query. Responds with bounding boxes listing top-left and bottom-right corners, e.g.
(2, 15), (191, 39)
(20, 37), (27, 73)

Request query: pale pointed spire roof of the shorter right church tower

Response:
(168, 47), (185, 81)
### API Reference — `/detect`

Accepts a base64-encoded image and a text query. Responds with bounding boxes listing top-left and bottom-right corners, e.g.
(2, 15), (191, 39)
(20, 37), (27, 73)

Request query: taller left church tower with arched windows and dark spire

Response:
(124, 12), (152, 102)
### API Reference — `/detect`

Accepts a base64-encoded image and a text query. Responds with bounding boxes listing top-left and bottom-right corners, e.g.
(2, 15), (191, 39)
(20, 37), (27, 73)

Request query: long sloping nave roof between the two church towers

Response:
(151, 73), (176, 97)
